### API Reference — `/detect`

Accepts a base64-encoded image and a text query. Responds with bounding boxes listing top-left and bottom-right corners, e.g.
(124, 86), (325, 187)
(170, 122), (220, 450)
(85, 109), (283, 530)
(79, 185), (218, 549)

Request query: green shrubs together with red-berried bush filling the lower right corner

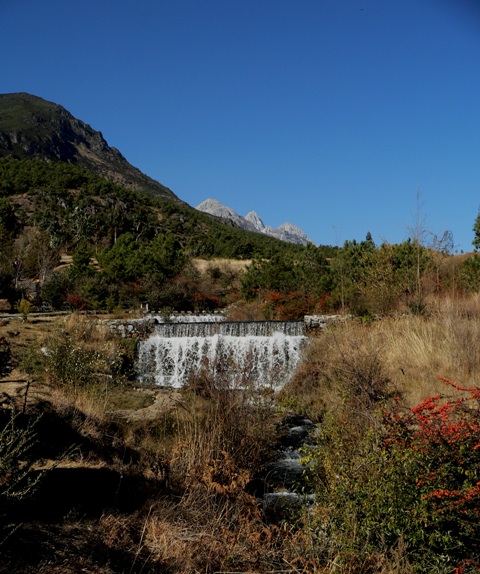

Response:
(310, 381), (480, 574)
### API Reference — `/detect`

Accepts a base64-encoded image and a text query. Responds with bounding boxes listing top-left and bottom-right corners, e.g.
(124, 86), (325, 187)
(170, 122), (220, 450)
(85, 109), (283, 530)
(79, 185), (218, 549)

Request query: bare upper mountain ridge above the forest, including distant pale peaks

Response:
(0, 92), (311, 250)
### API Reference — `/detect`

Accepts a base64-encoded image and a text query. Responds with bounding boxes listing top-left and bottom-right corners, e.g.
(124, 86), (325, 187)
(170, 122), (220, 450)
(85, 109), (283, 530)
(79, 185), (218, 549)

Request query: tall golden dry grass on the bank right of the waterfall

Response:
(282, 295), (480, 418)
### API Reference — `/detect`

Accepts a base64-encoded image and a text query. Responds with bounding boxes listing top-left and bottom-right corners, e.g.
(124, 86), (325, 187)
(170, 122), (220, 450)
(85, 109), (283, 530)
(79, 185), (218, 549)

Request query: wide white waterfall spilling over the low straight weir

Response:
(137, 321), (306, 388)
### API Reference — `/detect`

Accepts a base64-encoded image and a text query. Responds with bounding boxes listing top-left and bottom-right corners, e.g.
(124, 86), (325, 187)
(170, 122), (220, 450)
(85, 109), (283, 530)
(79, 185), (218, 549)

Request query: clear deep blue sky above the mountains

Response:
(0, 0), (480, 251)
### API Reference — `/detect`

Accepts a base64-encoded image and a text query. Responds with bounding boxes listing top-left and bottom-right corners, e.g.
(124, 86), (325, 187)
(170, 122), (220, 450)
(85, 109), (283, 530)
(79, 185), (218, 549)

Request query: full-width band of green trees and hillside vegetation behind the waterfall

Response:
(0, 158), (480, 319)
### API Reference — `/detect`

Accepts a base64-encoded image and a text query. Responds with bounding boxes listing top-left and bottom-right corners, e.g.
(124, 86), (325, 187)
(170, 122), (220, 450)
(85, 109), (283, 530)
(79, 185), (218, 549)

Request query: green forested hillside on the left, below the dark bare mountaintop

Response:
(0, 158), (338, 316)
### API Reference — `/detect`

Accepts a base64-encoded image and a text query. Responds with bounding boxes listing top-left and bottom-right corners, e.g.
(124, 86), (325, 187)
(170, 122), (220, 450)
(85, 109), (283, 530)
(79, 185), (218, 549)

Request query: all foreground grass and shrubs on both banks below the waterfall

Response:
(0, 306), (480, 574)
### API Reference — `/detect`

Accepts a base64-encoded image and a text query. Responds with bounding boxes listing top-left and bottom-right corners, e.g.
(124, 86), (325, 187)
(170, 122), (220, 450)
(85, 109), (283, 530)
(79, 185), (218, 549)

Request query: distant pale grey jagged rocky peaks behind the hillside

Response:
(195, 199), (313, 245)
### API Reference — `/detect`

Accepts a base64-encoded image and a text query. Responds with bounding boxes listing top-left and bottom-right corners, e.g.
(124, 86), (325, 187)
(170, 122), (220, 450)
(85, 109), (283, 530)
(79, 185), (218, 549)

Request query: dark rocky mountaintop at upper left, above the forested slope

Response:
(0, 93), (180, 202)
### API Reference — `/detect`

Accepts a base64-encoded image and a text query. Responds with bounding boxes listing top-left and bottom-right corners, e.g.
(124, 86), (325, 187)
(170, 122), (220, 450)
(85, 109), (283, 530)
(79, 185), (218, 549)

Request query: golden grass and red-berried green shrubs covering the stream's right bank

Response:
(283, 297), (480, 574)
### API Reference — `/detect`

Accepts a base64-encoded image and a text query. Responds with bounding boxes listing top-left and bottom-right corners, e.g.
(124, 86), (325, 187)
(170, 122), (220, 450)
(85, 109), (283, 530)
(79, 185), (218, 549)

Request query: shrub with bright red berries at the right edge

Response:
(384, 379), (480, 571)
